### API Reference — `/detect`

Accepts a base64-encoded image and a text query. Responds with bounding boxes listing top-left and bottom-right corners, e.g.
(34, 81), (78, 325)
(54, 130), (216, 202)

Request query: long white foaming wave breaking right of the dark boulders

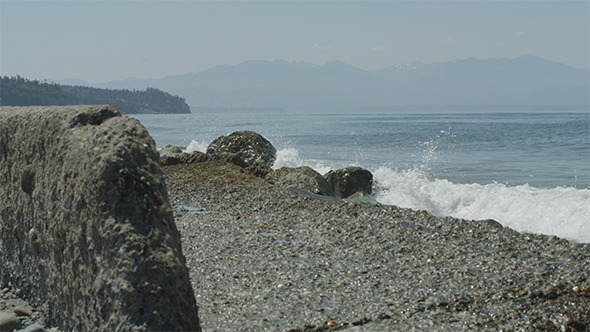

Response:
(373, 167), (590, 243)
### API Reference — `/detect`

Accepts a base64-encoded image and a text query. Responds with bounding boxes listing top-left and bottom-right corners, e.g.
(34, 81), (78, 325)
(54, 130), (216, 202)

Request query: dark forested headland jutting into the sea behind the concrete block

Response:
(0, 76), (190, 114)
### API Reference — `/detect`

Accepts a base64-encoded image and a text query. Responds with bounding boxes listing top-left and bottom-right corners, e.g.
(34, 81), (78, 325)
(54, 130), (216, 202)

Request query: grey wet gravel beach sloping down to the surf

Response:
(164, 162), (590, 331)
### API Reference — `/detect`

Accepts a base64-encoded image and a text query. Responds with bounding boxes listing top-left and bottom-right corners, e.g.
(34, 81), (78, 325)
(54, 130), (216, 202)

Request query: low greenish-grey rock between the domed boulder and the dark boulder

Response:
(265, 166), (334, 196)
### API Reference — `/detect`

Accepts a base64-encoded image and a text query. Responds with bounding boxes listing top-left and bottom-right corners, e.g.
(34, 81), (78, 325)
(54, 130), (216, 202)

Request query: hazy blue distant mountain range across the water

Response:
(61, 56), (590, 112)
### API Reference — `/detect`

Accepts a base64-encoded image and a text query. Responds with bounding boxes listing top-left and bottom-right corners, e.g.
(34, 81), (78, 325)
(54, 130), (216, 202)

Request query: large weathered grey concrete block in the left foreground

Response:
(0, 106), (200, 331)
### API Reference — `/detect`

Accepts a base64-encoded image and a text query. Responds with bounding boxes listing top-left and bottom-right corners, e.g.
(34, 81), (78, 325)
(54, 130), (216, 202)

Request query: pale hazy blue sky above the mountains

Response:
(0, 0), (590, 83)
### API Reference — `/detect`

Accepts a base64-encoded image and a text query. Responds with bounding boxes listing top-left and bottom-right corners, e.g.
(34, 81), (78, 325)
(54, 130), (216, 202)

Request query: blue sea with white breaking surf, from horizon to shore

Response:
(134, 112), (590, 243)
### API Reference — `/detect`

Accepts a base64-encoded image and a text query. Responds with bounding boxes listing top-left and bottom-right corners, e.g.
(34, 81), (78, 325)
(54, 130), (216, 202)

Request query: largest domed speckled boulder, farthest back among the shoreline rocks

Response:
(207, 131), (277, 168)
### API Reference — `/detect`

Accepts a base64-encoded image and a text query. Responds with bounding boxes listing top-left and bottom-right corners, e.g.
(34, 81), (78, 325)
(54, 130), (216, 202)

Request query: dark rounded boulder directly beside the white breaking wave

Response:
(324, 167), (373, 198)
